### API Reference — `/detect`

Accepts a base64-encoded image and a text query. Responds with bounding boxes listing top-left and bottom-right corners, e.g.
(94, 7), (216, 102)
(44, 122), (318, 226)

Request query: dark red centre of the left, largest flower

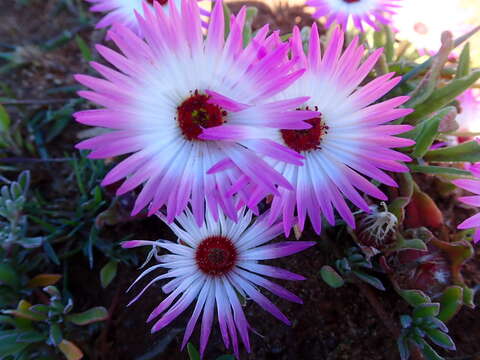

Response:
(177, 90), (227, 140)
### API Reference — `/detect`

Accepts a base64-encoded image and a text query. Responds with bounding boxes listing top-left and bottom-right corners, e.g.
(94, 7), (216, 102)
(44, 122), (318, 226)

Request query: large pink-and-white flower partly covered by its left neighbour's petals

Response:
(246, 25), (413, 233)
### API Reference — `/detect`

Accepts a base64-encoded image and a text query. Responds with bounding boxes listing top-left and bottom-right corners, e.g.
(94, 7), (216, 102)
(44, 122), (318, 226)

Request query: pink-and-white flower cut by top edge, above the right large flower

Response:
(306, 0), (401, 31)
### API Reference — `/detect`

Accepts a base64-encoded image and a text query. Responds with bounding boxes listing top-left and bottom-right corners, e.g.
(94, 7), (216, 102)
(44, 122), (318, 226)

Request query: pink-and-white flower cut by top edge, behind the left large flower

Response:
(85, 0), (209, 35)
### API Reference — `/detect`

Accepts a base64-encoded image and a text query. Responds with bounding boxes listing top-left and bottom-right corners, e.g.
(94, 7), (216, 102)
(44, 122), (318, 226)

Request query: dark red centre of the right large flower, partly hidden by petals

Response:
(281, 112), (328, 152)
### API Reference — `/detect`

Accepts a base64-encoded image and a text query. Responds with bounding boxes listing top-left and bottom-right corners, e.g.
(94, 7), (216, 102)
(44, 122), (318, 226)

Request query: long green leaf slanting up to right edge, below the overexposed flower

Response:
(405, 70), (480, 124)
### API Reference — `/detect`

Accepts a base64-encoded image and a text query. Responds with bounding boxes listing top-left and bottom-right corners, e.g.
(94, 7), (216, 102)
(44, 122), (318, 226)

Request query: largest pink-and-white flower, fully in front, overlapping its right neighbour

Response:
(75, 0), (313, 225)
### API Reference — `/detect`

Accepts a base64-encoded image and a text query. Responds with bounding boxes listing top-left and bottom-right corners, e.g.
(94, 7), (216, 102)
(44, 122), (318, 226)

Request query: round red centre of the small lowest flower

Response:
(195, 236), (238, 276)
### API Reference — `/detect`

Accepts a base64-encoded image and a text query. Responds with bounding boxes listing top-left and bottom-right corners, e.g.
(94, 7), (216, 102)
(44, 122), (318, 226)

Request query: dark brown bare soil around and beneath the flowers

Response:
(0, 0), (480, 360)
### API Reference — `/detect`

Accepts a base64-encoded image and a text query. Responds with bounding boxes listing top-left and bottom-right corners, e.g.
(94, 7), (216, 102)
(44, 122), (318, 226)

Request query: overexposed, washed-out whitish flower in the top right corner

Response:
(392, 0), (472, 55)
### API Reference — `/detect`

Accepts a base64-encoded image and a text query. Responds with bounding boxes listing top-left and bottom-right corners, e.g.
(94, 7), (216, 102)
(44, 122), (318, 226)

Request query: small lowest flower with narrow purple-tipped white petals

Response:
(122, 210), (315, 358)
